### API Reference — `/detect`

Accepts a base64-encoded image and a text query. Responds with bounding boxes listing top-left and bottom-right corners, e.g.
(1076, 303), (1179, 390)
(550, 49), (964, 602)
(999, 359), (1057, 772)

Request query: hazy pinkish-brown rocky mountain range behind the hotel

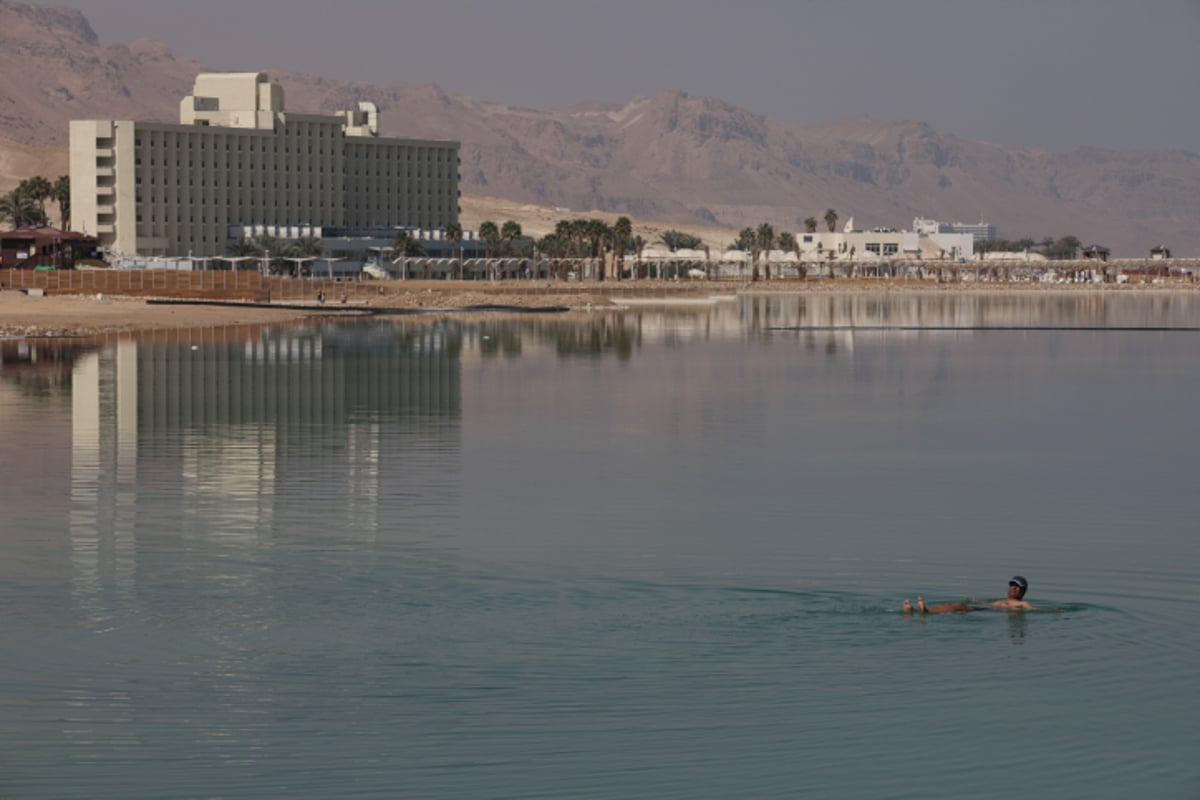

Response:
(0, 0), (1200, 257)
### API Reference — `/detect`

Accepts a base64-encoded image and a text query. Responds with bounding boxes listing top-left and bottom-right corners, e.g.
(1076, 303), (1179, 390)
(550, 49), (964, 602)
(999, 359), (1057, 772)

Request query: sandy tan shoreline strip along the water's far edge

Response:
(0, 278), (1200, 339)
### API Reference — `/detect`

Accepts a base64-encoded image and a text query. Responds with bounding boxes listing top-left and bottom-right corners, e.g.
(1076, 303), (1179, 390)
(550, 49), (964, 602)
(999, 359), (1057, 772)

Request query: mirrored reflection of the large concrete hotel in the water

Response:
(70, 327), (461, 588)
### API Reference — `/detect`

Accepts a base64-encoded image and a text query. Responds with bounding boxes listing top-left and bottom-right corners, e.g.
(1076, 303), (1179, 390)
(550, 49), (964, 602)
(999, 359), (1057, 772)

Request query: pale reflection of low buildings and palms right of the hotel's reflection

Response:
(396, 291), (1200, 360)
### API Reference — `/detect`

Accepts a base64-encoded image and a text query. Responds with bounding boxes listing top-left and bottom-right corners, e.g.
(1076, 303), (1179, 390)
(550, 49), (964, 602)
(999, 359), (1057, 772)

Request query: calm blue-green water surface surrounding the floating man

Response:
(0, 295), (1200, 799)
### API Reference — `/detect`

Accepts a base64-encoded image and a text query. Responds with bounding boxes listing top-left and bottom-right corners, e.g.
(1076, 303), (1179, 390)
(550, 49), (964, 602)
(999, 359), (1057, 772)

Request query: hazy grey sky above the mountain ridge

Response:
(37, 0), (1200, 151)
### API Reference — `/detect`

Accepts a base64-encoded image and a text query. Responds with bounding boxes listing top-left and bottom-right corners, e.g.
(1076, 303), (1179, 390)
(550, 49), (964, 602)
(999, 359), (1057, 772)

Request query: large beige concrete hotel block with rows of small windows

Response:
(71, 73), (458, 257)
